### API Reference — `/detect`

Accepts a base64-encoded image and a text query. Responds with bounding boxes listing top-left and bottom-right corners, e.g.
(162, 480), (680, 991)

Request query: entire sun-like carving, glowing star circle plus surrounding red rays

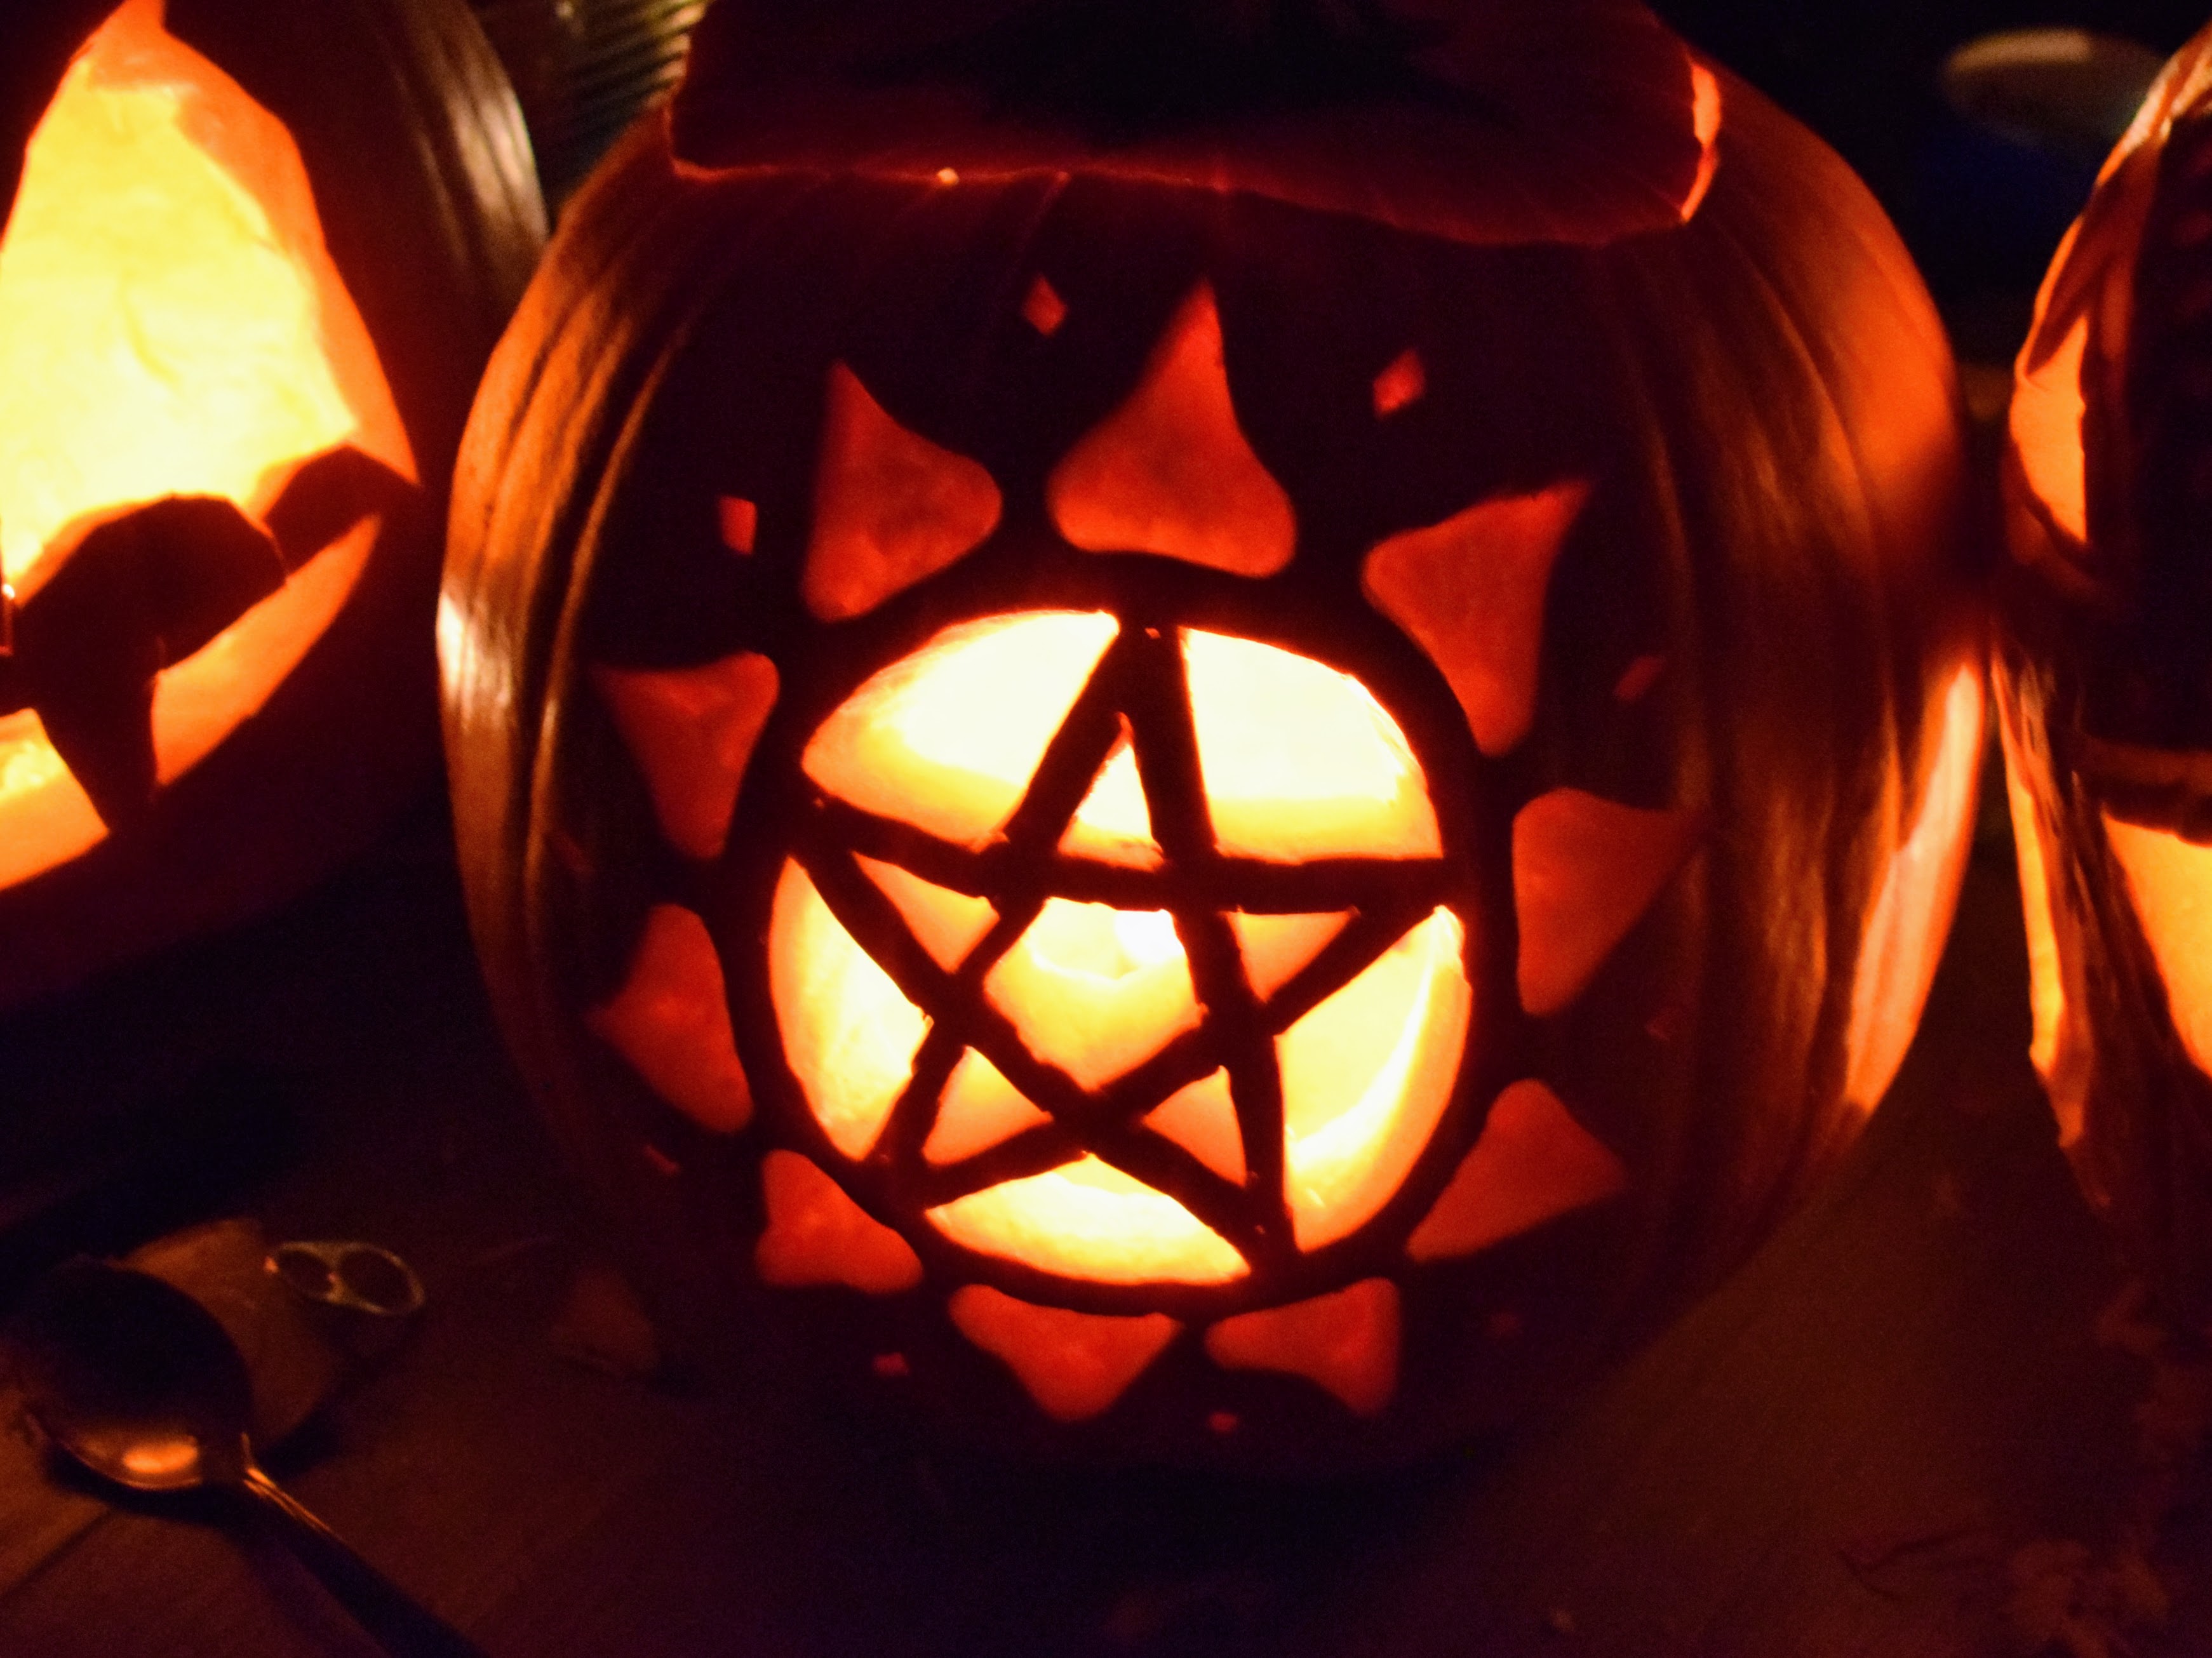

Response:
(591, 283), (1703, 1421)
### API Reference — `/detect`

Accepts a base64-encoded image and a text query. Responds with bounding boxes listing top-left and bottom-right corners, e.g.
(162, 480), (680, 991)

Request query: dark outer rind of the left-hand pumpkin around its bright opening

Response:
(0, 0), (544, 1004)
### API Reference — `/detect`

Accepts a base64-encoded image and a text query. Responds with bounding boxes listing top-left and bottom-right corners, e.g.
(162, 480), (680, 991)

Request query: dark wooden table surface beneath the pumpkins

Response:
(0, 782), (2212, 1658)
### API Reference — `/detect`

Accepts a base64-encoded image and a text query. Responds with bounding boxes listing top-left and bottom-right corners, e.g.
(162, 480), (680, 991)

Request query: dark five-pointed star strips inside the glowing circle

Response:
(794, 615), (1447, 1273)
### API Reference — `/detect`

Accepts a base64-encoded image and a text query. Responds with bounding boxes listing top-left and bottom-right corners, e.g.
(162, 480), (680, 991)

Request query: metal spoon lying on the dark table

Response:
(11, 1260), (485, 1658)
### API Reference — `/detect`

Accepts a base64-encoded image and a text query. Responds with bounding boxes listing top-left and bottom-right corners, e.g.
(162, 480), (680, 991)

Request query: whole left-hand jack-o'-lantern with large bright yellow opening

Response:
(0, 0), (542, 1001)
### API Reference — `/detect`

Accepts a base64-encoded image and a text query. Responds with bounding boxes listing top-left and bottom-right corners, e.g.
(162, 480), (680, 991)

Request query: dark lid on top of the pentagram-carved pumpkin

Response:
(670, 0), (1721, 245)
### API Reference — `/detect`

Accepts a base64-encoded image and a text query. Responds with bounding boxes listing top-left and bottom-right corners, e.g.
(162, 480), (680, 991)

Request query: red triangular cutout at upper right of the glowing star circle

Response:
(1360, 479), (1590, 758)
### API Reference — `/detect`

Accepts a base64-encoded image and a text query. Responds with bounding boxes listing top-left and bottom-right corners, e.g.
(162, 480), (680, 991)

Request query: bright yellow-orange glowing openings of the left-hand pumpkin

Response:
(0, 0), (416, 886)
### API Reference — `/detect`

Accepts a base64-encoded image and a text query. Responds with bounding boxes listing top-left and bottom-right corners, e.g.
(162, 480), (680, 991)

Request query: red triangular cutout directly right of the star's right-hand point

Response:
(1513, 789), (1705, 1015)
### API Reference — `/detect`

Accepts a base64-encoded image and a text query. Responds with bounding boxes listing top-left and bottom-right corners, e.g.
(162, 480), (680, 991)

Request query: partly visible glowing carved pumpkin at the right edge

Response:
(1997, 22), (2212, 1322)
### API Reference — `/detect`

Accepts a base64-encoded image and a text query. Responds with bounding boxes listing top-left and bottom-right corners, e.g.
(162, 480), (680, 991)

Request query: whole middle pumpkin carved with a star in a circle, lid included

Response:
(440, 0), (1980, 1466)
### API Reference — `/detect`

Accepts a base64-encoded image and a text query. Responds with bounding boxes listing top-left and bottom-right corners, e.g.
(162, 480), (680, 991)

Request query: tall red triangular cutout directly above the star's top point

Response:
(1044, 283), (1299, 577)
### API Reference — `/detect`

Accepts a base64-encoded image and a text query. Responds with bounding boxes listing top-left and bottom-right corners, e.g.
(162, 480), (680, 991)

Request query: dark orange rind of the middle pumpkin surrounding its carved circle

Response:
(440, 6), (1980, 1466)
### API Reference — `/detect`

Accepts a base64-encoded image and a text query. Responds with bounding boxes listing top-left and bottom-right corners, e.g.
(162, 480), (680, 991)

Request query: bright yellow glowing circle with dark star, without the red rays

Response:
(768, 612), (1473, 1289)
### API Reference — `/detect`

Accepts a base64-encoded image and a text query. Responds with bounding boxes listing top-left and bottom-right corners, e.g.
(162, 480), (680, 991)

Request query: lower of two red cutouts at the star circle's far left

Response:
(584, 904), (752, 1134)
